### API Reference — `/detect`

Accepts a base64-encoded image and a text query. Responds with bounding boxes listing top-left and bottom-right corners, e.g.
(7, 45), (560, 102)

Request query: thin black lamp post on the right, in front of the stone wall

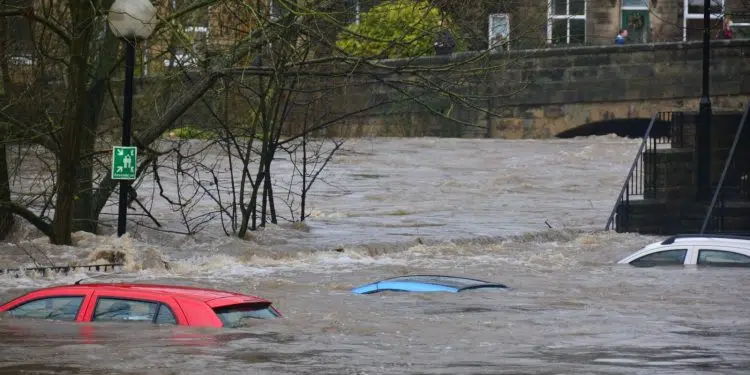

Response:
(695, 0), (712, 200)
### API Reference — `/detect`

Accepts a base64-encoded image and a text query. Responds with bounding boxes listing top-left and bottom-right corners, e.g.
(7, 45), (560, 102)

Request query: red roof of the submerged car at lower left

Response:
(40, 283), (270, 303)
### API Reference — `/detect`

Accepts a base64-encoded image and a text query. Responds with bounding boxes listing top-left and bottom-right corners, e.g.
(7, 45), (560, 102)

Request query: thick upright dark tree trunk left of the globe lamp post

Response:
(51, 0), (95, 245)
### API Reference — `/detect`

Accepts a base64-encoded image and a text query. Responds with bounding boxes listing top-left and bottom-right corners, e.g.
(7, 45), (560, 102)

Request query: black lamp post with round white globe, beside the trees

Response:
(107, 0), (156, 237)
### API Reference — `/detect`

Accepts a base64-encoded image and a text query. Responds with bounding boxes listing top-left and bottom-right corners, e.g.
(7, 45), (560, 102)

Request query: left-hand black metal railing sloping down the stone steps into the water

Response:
(604, 112), (682, 231)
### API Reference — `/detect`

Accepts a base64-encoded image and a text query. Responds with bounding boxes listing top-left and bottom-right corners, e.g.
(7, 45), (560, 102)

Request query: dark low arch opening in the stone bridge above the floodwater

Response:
(555, 118), (669, 138)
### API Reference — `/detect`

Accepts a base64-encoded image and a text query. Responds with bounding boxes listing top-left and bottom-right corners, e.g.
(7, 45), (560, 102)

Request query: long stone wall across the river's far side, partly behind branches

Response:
(79, 40), (750, 138)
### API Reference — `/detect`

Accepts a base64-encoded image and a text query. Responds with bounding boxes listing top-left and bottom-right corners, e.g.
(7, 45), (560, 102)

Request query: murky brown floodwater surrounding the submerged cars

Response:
(0, 137), (750, 375)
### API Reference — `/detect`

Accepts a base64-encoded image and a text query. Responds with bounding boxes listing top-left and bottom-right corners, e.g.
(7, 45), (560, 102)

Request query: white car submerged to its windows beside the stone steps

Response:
(617, 234), (750, 267)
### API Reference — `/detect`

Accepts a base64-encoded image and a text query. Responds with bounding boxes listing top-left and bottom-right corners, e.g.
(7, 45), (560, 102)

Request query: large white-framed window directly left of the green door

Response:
(547, 0), (586, 45)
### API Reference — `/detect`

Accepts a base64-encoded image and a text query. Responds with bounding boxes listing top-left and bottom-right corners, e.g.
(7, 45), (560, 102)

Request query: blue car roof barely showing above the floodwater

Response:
(352, 275), (508, 294)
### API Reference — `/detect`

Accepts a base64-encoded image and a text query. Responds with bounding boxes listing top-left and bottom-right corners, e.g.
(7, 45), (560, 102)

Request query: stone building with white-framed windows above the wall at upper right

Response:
(452, 0), (750, 49)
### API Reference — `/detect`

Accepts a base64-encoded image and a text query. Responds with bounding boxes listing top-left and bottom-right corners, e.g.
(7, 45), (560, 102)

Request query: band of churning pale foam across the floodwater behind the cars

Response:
(0, 230), (656, 289)
